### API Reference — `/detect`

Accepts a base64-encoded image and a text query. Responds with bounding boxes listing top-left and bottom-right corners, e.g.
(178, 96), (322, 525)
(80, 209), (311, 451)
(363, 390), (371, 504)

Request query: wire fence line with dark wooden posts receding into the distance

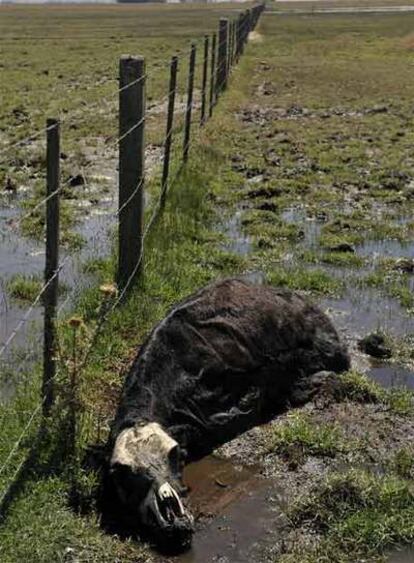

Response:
(0, 0), (264, 504)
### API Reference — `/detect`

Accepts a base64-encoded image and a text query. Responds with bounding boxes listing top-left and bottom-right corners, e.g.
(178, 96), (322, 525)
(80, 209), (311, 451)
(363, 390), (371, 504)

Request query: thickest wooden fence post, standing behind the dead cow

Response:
(117, 55), (145, 290)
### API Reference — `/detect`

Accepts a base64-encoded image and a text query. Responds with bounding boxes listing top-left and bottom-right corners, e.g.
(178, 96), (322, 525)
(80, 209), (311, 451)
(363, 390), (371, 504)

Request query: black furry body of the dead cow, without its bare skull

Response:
(110, 279), (349, 460)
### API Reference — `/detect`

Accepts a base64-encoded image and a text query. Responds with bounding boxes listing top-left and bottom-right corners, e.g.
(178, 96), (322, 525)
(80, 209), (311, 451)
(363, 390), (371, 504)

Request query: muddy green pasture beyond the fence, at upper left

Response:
(0, 4), (246, 246)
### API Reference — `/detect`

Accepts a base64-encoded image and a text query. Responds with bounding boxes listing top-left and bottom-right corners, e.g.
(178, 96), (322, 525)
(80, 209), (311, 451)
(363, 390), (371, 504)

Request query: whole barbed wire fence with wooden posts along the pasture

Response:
(0, 4), (264, 506)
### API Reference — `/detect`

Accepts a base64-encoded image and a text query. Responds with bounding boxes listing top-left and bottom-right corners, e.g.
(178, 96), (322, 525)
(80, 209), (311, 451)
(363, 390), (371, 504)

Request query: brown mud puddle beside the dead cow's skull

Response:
(165, 456), (282, 563)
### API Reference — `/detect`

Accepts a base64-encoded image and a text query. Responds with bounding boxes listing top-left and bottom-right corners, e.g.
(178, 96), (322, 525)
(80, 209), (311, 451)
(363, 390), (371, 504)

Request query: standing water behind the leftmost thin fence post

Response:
(0, 186), (115, 401)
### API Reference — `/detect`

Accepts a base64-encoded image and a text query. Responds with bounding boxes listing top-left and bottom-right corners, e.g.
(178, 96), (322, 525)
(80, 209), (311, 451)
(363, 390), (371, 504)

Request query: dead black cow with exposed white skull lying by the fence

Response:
(106, 279), (349, 545)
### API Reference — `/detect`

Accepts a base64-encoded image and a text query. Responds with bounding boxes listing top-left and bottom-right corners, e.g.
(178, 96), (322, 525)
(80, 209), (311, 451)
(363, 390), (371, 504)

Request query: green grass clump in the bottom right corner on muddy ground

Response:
(290, 470), (414, 562)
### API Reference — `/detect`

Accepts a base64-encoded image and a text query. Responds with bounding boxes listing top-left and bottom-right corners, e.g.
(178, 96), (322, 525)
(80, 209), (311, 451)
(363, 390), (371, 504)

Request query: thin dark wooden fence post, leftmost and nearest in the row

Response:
(42, 119), (60, 416)
